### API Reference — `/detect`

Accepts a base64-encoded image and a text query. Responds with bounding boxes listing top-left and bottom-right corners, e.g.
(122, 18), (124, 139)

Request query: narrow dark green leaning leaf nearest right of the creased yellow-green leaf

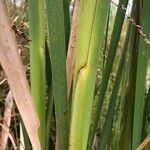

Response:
(89, 0), (128, 149)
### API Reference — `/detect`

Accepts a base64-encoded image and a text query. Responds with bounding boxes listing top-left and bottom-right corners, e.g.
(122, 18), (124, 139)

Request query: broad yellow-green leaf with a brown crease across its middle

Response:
(69, 0), (109, 150)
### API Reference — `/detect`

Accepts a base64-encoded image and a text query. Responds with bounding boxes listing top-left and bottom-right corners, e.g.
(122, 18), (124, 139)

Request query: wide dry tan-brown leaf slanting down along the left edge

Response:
(0, 0), (41, 150)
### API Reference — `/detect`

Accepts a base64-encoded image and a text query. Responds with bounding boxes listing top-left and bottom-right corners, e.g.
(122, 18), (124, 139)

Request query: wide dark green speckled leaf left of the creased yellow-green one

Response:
(46, 0), (69, 150)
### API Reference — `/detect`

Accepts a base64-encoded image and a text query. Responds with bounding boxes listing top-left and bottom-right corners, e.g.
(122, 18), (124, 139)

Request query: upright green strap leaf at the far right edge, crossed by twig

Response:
(132, 0), (150, 150)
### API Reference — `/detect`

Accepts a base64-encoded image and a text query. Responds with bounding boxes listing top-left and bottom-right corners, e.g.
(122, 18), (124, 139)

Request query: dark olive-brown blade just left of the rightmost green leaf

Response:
(119, 2), (139, 150)
